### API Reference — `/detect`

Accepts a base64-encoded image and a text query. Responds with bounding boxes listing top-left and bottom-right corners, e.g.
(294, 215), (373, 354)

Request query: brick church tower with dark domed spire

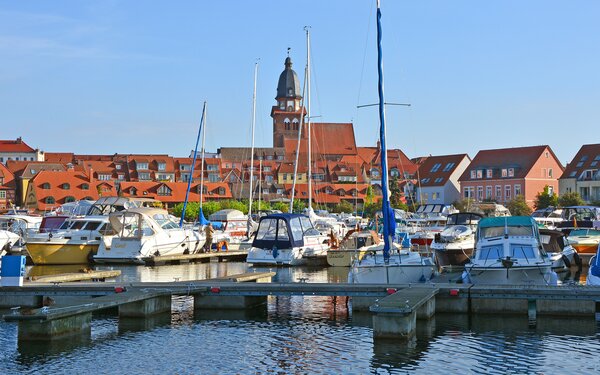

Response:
(271, 56), (306, 147)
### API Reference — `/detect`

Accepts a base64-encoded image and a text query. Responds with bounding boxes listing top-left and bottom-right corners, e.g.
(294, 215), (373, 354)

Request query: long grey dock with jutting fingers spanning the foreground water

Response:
(0, 282), (600, 340)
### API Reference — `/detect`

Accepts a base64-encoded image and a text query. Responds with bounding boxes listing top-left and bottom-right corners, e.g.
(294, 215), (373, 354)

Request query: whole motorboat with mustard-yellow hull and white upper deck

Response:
(26, 216), (111, 265)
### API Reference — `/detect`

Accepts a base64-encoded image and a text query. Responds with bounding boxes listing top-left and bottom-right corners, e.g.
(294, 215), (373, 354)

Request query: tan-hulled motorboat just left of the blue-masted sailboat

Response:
(327, 229), (381, 267)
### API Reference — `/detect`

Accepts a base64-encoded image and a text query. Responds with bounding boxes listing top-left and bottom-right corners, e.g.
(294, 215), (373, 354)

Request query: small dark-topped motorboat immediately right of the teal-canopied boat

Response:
(536, 228), (582, 270)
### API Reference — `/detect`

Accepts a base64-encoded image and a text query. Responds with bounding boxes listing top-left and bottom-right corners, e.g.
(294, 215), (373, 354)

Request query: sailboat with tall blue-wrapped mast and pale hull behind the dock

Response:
(348, 0), (436, 284)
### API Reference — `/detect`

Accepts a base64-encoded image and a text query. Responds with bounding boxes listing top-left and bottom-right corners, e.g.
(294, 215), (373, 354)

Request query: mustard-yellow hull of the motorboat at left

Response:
(26, 242), (98, 265)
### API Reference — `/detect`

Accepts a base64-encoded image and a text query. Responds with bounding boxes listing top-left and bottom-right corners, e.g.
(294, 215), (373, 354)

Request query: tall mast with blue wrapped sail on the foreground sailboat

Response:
(377, 0), (396, 263)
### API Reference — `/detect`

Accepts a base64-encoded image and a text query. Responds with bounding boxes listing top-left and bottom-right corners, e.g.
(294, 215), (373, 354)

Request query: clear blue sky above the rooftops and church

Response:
(0, 0), (600, 164)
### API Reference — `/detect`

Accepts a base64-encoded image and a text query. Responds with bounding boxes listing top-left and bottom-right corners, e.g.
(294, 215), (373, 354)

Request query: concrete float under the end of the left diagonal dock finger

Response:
(18, 312), (92, 341)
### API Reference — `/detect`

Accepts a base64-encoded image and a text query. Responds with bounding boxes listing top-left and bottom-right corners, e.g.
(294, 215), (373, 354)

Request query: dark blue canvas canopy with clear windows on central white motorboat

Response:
(252, 214), (319, 249)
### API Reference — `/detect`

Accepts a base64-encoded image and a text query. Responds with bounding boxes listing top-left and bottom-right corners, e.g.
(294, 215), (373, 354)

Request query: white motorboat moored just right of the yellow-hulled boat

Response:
(94, 207), (204, 264)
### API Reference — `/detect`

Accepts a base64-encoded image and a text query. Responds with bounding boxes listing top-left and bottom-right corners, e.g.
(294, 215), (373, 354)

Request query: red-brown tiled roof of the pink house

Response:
(459, 145), (562, 181)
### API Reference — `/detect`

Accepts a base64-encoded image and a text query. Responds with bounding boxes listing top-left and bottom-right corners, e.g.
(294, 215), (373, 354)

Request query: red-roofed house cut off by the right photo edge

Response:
(558, 143), (600, 203)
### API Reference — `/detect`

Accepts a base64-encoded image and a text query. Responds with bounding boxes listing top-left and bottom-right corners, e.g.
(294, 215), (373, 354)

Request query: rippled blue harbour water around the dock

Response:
(0, 263), (600, 374)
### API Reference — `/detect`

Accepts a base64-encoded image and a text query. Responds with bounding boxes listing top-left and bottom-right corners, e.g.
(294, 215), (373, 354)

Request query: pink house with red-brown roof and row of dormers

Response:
(459, 145), (564, 207)
